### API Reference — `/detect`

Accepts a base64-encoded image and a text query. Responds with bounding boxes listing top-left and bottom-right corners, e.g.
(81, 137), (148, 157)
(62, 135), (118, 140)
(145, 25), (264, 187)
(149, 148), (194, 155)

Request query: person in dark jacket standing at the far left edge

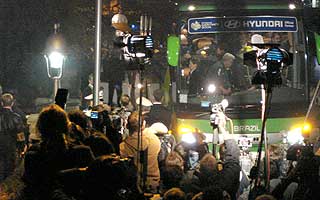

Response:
(0, 93), (25, 182)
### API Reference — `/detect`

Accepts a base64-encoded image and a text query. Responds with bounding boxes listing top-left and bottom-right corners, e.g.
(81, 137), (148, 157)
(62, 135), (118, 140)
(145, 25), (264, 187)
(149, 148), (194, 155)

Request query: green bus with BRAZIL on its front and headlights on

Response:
(168, 0), (320, 164)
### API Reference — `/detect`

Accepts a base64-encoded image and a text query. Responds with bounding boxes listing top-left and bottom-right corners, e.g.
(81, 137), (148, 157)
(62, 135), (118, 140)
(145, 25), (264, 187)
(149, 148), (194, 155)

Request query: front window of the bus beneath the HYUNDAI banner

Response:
(178, 26), (305, 108)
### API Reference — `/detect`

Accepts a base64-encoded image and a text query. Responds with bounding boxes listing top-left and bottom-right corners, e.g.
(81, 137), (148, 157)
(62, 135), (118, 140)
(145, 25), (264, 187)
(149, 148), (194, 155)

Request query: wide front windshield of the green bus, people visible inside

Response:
(177, 16), (306, 114)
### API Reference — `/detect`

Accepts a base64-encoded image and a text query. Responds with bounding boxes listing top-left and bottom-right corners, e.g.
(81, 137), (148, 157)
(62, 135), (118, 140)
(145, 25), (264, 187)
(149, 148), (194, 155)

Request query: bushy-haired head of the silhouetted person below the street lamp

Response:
(36, 104), (70, 140)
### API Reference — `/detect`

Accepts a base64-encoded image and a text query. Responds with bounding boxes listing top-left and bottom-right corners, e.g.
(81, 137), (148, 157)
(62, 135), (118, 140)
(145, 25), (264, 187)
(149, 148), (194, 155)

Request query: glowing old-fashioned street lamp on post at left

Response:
(44, 24), (65, 98)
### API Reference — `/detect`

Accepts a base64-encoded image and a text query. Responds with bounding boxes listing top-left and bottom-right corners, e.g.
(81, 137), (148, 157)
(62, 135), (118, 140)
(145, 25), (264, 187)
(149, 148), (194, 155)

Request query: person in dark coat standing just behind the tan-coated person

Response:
(146, 89), (172, 129)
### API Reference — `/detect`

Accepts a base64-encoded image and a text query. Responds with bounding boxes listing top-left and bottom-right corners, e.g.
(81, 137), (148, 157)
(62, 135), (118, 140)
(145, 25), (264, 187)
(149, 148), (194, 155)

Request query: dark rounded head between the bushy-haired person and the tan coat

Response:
(85, 132), (115, 157)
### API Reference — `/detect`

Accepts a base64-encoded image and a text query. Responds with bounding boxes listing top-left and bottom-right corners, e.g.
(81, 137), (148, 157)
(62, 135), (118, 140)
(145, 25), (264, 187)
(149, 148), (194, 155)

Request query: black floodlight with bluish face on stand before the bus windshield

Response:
(243, 38), (293, 196)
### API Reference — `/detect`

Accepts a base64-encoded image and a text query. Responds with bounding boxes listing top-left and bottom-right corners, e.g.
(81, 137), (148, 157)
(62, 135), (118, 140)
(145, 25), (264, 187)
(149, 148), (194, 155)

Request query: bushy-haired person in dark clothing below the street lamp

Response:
(23, 105), (94, 200)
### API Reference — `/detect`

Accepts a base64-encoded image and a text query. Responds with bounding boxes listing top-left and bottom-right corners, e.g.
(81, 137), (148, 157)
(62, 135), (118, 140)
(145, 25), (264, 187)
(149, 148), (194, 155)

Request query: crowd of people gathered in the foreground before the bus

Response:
(0, 85), (320, 200)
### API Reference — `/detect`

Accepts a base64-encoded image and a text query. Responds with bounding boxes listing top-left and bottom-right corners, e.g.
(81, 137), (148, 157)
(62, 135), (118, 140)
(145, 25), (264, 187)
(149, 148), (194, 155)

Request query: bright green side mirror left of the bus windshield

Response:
(167, 36), (180, 67)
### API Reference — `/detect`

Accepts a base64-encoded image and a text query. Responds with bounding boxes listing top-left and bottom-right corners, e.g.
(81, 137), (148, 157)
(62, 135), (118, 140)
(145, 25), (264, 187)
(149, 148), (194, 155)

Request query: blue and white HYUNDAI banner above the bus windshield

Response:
(188, 16), (298, 34)
